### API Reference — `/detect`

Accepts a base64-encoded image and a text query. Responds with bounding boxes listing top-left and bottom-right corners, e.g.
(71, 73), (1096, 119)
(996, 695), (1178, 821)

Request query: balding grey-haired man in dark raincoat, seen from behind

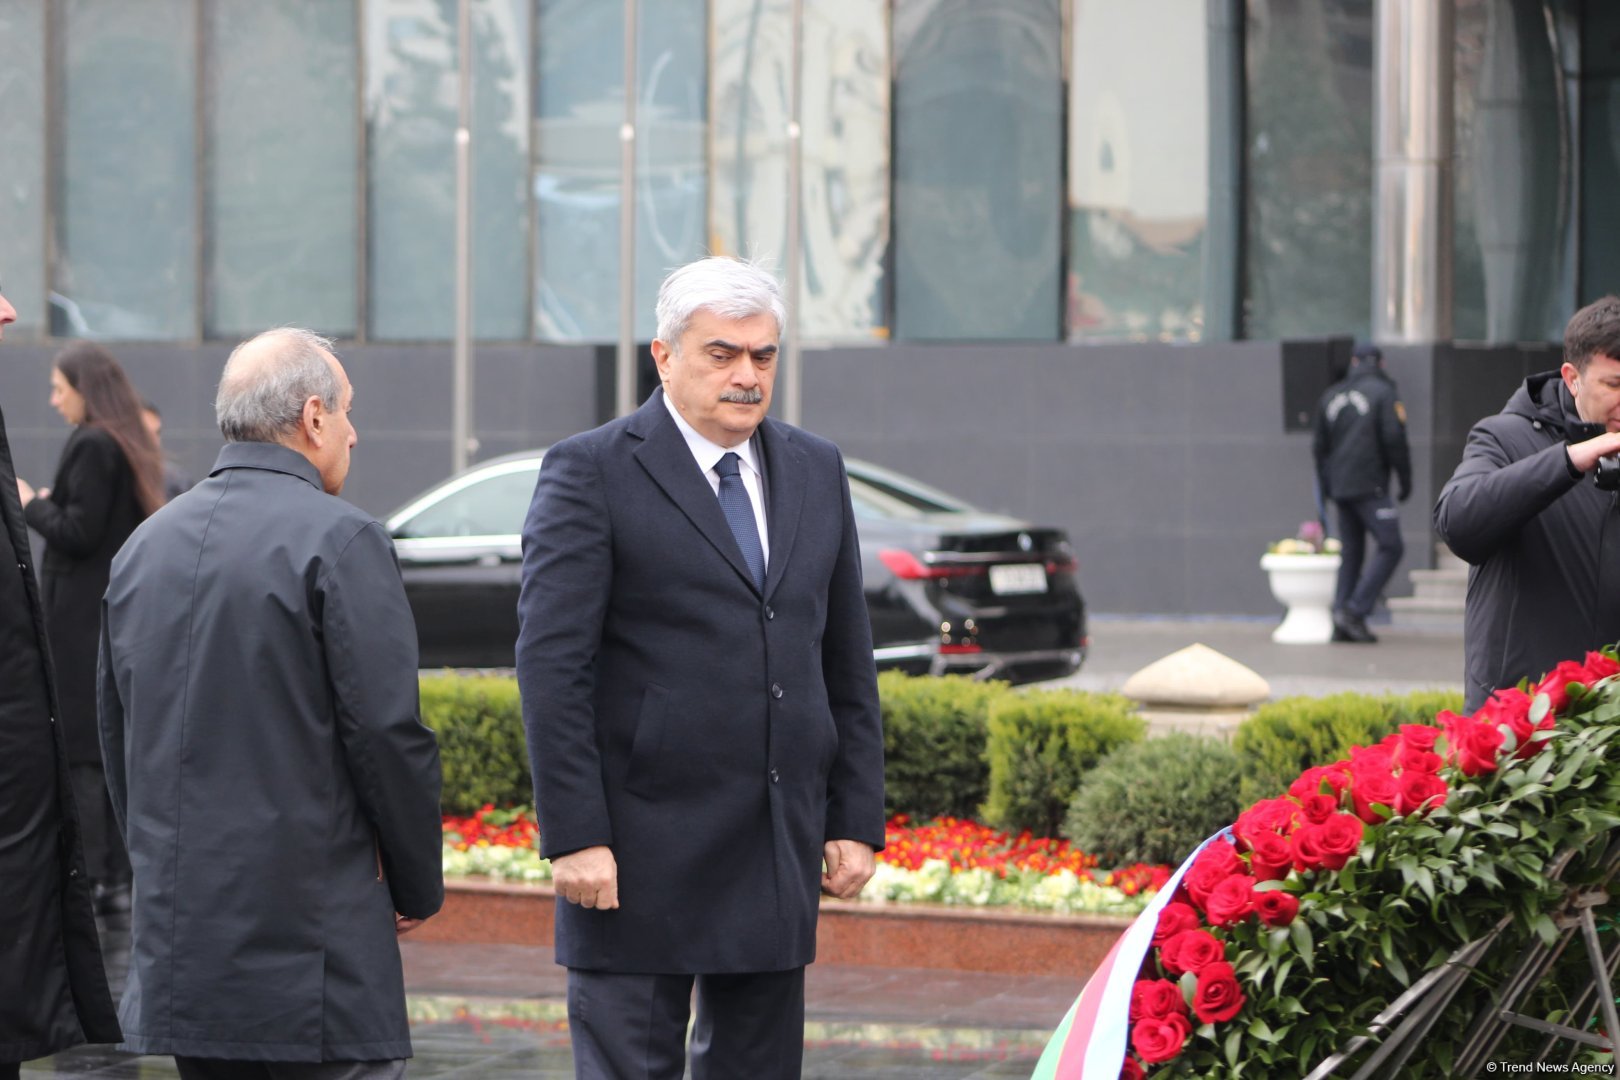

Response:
(100, 330), (444, 1080)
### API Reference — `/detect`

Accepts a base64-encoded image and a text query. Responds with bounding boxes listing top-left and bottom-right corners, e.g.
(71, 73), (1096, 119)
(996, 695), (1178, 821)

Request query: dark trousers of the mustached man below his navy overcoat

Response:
(569, 968), (805, 1080)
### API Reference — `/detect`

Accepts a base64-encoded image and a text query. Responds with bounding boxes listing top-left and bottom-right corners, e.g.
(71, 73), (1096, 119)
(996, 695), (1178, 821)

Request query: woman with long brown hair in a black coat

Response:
(18, 342), (164, 912)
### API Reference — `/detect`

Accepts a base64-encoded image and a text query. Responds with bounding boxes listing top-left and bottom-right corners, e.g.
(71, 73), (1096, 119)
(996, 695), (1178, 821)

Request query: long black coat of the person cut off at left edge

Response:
(0, 399), (120, 1062)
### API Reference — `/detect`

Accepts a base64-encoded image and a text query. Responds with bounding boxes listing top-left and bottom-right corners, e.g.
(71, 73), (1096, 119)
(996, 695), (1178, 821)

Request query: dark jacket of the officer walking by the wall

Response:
(1311, 363), (1413, 502)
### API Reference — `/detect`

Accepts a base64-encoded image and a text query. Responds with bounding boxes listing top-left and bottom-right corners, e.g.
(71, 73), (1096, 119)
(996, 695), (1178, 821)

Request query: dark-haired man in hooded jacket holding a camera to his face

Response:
(1434, 296), (1620, 712)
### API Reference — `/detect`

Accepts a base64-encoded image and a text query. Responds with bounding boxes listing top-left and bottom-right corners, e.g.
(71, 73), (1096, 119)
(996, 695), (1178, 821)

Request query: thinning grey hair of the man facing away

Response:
(214, 327), (342, 442)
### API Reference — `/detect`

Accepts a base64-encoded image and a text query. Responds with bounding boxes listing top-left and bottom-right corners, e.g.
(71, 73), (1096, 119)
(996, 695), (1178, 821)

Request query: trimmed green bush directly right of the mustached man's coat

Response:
(878, 672), (1011, 819)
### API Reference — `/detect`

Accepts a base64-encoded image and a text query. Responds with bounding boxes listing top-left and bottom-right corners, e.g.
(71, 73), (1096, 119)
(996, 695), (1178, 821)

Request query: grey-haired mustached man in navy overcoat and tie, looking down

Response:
(517, 259), (883, 1080)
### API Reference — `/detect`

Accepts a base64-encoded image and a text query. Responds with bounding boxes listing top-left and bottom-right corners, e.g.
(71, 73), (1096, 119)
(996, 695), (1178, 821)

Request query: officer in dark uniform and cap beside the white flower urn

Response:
(1311, 342), (1413, 643)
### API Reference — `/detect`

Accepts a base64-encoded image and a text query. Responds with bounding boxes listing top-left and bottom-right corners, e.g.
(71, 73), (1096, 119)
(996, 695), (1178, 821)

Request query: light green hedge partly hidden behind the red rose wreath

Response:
(1231, 690), (1463, 805)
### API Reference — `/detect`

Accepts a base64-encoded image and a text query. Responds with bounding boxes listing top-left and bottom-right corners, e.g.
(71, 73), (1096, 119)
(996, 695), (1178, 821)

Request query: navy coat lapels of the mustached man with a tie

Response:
(625, 389), (805, 599)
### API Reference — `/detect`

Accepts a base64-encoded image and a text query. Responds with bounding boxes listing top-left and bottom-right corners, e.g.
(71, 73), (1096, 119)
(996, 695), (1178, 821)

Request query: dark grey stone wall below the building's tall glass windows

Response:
(0, 342), (1557, 615)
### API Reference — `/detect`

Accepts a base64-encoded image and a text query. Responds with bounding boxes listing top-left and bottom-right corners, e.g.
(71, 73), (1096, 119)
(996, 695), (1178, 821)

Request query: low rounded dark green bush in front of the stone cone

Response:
(1063, 732), (1246, 866)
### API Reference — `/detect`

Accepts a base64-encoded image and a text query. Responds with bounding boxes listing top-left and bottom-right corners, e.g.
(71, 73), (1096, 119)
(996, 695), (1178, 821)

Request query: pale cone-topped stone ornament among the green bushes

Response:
(1119, 643), (1272, 738)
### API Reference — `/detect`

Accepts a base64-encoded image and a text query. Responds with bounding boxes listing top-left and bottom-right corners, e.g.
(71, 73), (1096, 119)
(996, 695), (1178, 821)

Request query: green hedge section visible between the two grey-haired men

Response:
(421, 672), (535, 814)
